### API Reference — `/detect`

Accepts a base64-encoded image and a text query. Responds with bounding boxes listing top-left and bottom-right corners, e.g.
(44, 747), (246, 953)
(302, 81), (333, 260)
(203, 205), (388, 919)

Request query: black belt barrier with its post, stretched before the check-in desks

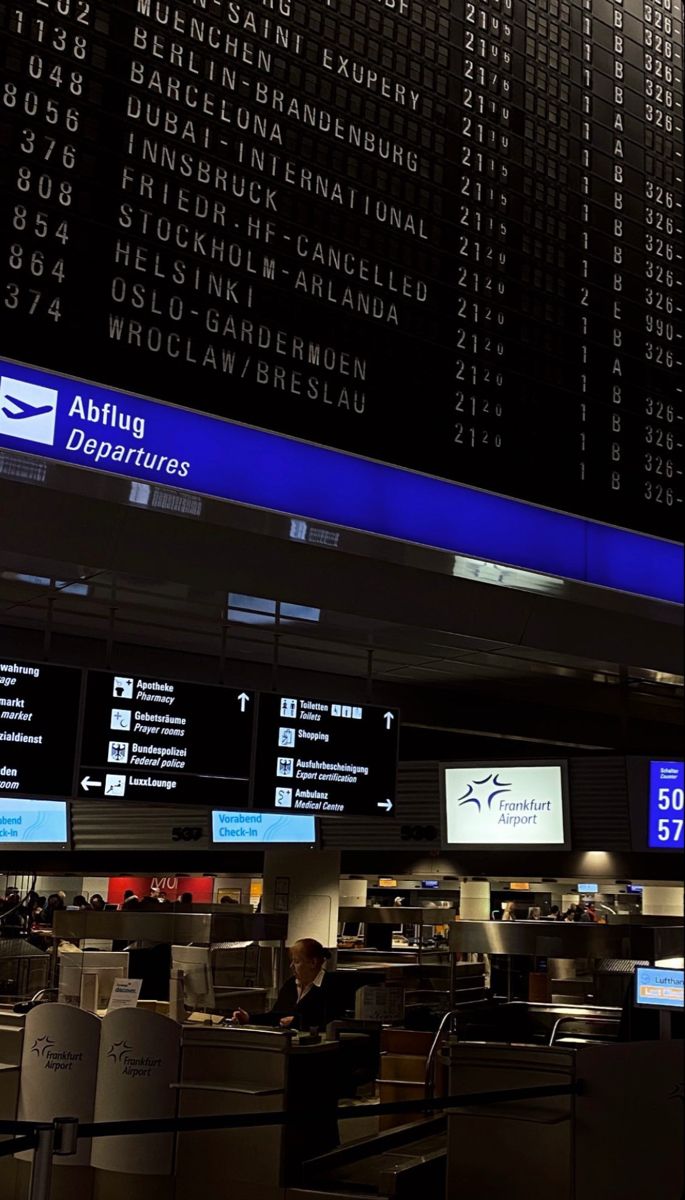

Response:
(0, 1081), (581, 1200)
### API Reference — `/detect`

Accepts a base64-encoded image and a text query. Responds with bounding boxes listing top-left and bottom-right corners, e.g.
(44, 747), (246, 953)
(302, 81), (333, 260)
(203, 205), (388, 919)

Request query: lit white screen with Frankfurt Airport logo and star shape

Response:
(443, 763), (567, 848)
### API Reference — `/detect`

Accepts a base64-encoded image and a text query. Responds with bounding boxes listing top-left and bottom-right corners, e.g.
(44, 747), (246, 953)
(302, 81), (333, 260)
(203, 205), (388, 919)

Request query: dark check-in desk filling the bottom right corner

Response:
(446, 1042), (683, 1200)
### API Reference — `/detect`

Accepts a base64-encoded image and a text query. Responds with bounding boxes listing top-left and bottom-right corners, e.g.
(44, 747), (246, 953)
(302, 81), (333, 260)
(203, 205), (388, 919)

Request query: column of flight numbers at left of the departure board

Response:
(0, 0), (95, 328)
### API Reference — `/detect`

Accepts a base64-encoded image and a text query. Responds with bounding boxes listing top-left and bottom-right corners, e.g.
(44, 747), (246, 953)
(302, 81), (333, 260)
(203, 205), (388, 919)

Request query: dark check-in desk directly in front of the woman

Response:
(176, 1025), (340, 1200)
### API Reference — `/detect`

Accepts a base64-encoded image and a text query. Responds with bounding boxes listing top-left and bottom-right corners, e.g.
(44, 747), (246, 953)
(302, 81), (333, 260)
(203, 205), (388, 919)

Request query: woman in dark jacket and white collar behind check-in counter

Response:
(233, 937), (344, 1030)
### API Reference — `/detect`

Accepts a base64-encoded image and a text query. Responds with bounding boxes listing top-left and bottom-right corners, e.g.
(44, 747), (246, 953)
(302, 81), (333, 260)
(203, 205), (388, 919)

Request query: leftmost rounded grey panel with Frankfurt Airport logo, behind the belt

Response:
(17, 1004), (101, 1166)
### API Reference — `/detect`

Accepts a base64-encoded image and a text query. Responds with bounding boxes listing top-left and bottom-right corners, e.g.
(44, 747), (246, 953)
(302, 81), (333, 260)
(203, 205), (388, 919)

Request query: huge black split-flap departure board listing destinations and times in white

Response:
(0, 0), (683, 536)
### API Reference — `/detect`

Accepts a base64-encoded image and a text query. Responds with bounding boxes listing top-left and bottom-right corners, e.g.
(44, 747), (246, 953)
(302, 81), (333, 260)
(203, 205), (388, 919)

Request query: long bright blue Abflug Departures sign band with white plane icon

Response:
(0, 352), (684, 604)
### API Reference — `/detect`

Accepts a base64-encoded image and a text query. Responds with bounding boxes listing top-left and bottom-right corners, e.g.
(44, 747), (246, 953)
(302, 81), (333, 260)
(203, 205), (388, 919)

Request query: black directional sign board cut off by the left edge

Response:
(0, 659), (82, 797)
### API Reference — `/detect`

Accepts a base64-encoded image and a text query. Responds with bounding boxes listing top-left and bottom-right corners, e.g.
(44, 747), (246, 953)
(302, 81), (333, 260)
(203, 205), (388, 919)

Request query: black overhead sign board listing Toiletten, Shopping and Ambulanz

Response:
(253, 695), (399, 817)
